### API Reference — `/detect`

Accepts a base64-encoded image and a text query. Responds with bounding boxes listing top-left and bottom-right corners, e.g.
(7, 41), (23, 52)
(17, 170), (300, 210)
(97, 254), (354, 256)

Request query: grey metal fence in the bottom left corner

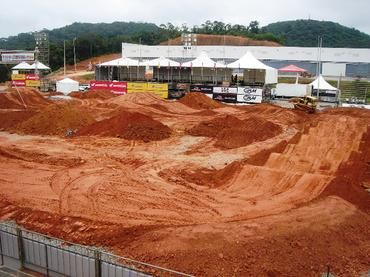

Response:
(0, 223), (191, 277)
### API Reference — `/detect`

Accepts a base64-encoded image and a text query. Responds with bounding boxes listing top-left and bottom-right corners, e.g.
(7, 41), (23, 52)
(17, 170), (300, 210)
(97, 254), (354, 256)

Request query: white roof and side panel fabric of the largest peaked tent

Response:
(227, 51), (278, 84)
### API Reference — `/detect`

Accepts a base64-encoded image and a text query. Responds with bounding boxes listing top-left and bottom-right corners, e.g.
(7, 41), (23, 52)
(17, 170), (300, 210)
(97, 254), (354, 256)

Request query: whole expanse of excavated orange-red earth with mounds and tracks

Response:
(0, 89), (370, 276)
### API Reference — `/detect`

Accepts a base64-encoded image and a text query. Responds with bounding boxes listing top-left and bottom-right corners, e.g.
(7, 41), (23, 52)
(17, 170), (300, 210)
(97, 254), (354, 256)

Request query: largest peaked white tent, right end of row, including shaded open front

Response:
(227, 51), (278, 84)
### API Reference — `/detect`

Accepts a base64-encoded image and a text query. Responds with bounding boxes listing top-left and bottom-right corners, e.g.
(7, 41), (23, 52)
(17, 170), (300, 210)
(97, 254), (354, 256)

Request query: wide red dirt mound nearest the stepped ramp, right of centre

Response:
(188, 115), (282, 149)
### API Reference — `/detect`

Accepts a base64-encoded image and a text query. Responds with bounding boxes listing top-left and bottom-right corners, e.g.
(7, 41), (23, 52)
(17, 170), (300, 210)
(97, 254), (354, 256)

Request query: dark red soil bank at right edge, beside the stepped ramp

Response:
(321, 127), (370, 214)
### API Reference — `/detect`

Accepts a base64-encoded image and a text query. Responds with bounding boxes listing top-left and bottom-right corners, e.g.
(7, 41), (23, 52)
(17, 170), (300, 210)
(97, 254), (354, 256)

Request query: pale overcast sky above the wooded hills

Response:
(0, 0), (370, 37)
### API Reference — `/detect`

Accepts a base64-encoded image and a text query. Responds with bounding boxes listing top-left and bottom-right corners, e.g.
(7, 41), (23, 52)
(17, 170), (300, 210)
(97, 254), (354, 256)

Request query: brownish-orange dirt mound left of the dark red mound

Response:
(17, 104), (95, 136)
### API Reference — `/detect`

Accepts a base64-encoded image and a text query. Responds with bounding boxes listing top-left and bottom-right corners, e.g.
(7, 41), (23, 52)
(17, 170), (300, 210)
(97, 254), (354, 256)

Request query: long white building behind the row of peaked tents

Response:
(122, 43), (370, 78)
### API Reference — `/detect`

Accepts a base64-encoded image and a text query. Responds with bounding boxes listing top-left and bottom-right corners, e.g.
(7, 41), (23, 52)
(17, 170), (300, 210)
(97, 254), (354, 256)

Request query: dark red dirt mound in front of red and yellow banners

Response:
(77, 111), (171, 142)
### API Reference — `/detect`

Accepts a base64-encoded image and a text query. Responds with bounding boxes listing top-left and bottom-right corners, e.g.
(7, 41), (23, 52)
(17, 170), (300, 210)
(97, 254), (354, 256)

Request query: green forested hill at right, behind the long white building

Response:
(262, 20), (370, 48)
